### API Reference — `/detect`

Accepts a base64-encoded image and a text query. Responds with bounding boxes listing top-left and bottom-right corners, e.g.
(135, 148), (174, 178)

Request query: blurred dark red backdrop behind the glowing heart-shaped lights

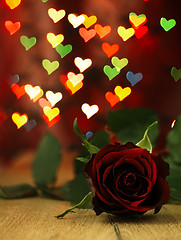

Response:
(0, 0), (181, 169)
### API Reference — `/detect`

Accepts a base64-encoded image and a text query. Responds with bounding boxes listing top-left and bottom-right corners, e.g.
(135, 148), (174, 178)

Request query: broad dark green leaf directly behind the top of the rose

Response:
(107, 108), (158, 146)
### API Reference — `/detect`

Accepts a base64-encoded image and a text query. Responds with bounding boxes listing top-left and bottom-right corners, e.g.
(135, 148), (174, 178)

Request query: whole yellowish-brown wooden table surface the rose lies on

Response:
(0, 151), (181, 240)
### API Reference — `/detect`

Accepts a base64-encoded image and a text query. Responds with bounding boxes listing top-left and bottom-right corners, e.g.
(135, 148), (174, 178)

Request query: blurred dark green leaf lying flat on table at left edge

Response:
(0, 184), (38, 199)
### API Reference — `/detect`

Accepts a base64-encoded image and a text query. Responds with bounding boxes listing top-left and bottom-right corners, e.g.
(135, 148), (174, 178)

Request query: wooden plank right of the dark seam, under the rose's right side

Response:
(108, 205), (181, 240)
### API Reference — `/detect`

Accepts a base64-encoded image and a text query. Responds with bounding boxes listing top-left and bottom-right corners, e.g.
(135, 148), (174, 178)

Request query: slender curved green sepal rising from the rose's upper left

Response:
(73, 118), (100, 154)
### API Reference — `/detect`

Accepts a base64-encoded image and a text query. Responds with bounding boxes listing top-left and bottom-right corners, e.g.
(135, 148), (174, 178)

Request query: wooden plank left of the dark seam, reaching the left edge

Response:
(0, 197), (116, 240)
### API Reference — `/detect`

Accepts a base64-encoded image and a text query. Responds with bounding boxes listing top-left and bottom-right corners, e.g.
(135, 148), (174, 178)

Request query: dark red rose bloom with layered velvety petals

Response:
(85, 142), (170, 215)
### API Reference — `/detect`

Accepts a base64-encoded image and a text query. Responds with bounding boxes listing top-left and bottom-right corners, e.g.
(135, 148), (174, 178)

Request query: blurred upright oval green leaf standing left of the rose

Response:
(33, 133), (61, 187)
